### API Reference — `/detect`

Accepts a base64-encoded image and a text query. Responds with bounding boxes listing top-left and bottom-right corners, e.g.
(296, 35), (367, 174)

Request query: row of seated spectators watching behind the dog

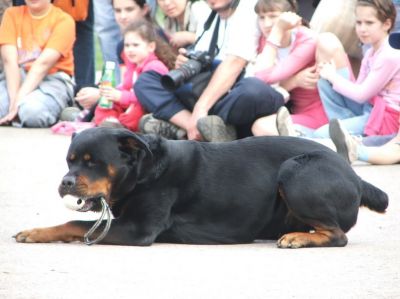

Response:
(0, 0), (400, 164)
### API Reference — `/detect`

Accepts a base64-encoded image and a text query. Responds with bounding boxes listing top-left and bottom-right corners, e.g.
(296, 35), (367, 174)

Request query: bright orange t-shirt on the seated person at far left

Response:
(0, 5), (75, 76)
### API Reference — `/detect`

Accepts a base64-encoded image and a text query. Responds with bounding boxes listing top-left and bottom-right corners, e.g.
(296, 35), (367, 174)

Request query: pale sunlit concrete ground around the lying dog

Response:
(0, 127), (400, 299)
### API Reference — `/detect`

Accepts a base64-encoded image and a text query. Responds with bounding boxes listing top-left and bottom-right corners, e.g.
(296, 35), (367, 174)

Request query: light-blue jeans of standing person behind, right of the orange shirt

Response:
(93, 0), (122, 85)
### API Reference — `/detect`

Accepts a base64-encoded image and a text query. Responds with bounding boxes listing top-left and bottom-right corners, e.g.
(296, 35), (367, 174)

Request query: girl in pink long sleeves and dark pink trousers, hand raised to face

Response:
(252, 0), (328, 135)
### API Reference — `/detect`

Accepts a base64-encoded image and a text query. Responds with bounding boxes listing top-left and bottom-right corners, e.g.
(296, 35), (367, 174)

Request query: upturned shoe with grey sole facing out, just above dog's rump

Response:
(329, 119), (358, 164)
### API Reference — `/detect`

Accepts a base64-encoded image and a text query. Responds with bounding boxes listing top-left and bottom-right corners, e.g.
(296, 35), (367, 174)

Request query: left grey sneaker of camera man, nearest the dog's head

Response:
(139, 113), (186, 140)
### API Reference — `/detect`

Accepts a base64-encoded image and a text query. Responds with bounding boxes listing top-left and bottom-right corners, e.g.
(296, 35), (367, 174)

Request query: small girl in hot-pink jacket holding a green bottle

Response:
(94, 20), (171, 131)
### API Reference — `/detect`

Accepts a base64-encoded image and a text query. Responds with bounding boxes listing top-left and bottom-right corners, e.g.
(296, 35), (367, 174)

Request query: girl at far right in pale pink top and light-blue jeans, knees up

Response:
(314, 0), (400, 137)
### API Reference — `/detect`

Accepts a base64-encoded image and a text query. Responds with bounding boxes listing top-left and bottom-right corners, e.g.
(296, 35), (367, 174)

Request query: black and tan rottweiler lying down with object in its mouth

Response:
(15, 128), (388, 248)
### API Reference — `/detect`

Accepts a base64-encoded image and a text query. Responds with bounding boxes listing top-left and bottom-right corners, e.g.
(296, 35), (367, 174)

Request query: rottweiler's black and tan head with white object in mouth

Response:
(58, 128), (152, 212)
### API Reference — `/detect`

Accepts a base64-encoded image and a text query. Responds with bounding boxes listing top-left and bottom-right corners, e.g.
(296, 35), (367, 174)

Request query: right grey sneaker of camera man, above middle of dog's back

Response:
(197, 115), (237, 142)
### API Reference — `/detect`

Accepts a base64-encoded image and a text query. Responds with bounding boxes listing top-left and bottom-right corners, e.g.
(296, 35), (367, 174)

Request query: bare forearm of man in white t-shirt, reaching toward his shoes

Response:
(195, 56), (247, 111)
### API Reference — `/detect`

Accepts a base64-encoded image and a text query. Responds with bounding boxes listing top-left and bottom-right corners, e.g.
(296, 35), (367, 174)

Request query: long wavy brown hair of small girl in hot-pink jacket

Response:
(124, 19), (176, 69)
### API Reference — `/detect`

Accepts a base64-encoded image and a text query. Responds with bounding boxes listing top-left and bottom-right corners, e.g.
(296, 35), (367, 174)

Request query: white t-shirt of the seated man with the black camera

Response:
(195, 0), (260, 61)
